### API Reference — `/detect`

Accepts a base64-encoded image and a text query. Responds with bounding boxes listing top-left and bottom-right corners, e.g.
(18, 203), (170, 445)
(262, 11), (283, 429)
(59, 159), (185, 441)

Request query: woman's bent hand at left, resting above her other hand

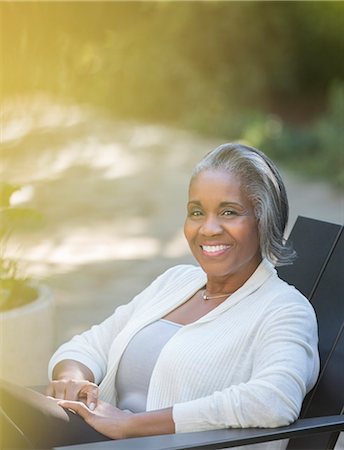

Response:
(46, 379), (99, 411)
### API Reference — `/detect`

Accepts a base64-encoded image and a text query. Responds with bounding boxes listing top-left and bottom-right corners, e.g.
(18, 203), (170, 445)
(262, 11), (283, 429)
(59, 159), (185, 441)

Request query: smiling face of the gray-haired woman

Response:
(184, 169), (262, 285)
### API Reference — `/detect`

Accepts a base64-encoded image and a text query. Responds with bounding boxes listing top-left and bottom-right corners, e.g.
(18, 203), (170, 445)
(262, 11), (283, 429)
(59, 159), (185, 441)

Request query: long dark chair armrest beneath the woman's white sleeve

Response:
(54, 415), (344, 450)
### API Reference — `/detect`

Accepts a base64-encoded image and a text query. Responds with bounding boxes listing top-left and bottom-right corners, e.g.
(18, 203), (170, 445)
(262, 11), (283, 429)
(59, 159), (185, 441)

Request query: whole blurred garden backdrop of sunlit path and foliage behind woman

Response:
(0, 1), (344, 354)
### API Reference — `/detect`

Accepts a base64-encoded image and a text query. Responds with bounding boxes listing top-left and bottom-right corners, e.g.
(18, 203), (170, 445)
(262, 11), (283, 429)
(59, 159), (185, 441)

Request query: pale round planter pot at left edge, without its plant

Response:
(0, 286), (54, 386)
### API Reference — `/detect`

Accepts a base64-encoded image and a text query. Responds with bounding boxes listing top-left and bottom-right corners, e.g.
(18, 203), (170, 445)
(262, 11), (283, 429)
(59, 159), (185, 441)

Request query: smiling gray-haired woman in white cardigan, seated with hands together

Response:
(0, 144), (319, 448)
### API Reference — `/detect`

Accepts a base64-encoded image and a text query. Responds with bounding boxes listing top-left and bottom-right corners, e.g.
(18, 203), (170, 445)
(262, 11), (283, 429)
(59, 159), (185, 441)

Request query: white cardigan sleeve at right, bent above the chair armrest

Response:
(173, 296), (319, 432)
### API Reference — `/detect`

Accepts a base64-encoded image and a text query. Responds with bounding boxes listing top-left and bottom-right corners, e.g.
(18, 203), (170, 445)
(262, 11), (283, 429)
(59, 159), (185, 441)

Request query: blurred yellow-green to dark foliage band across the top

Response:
(0, 1), (344, 114)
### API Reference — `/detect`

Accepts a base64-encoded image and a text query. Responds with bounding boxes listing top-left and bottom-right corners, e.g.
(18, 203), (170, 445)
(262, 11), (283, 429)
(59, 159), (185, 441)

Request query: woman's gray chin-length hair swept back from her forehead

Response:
(191, 143), (296, 266)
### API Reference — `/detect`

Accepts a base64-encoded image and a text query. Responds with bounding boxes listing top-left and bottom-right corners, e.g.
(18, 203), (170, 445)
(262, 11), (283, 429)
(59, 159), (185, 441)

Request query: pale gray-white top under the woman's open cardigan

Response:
(115, 319), (183, 413)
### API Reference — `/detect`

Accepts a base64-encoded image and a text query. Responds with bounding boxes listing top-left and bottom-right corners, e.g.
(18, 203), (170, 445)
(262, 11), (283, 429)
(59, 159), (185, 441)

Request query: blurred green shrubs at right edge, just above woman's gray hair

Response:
(244, 83), (344, 188)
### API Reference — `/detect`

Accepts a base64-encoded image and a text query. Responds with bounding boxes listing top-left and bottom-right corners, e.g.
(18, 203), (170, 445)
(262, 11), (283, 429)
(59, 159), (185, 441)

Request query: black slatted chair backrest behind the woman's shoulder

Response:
(278, 217), (344, 450)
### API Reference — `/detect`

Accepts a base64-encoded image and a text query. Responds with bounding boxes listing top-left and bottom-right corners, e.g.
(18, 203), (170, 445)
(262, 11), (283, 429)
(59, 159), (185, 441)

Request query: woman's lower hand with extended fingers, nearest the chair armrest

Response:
(58, 400), (134, 439)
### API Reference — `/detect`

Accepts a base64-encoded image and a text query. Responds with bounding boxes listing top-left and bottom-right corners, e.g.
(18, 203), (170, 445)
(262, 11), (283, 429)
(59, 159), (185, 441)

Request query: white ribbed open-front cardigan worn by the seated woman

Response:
(49, 260), (319, 432)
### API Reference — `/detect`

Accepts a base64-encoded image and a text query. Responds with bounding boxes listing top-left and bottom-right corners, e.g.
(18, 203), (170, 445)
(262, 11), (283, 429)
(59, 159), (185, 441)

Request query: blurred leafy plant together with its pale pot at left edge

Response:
(0, 183), (54, 385)
